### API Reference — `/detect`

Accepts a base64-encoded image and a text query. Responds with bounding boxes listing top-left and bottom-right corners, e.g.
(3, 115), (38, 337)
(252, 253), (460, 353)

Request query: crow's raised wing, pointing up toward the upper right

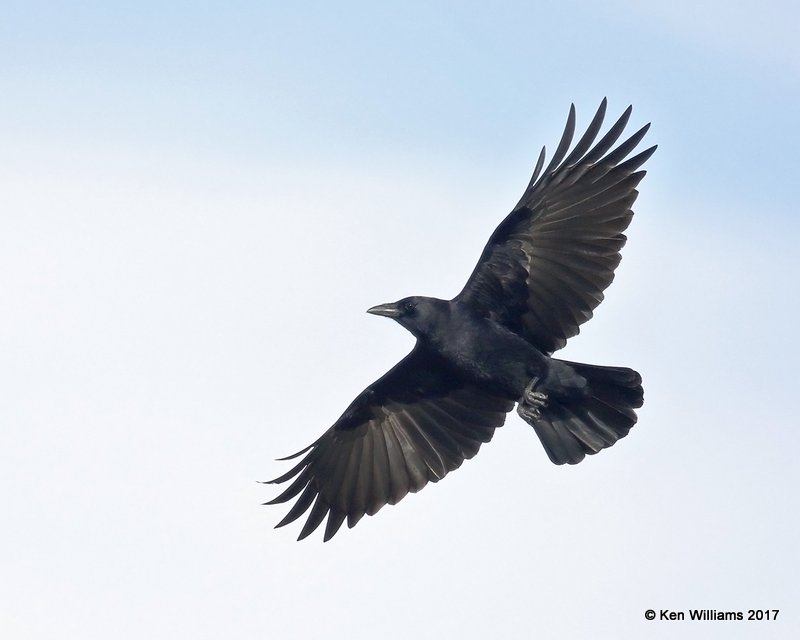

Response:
(456, 99), (656, 354)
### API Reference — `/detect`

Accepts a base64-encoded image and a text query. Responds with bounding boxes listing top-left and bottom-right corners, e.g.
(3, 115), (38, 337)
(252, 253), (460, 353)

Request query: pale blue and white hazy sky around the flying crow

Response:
(0, 0), (800, 640)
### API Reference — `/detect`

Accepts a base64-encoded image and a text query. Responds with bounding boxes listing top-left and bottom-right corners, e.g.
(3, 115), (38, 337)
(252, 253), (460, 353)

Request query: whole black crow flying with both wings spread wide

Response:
(266, 99), (656, 541)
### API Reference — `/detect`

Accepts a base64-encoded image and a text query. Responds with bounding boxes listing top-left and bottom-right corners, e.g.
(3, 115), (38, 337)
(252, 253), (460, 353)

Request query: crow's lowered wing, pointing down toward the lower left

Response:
(266, 345), (514, 540)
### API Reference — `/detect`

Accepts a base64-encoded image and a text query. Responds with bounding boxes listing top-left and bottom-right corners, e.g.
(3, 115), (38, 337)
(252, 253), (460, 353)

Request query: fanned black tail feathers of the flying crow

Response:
(523, 360), (644, 464)
